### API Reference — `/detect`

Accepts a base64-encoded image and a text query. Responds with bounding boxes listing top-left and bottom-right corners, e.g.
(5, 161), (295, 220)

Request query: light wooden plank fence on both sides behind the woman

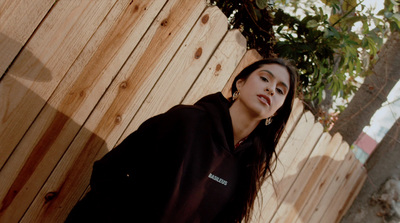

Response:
(0, 0), (366, 222)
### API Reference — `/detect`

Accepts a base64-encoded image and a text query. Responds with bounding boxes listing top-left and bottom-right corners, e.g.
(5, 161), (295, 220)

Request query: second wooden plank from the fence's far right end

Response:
(308, 151), (355, 223)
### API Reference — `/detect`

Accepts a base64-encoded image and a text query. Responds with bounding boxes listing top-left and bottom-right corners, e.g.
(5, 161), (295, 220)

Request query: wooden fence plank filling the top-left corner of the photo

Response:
(0, 0), (55, 79)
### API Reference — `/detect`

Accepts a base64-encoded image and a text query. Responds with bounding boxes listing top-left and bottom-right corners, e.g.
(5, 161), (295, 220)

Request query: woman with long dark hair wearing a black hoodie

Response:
(67, 59), (297, 223)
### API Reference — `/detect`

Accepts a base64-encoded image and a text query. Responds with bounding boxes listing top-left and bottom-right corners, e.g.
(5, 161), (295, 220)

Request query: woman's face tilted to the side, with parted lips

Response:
(235, 64), (290, 120)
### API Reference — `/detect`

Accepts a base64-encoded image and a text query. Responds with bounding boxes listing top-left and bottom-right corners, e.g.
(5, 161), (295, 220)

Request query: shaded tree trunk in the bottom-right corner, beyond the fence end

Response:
(341, 118), (400, 223)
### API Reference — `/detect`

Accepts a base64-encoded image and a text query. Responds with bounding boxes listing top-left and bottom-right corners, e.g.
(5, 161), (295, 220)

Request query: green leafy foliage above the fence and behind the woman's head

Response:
(211, 0), (400, 128)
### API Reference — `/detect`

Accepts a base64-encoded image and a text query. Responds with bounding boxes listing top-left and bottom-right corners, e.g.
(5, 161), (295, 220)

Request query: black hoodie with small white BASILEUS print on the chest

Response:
(67, 93), (252, 223)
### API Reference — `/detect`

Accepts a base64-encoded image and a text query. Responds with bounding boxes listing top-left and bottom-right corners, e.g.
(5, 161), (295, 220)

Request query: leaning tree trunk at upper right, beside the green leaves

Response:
(330, 32), (400, 144)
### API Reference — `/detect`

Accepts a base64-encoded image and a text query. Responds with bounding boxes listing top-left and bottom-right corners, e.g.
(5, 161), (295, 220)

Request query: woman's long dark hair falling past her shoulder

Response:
(231, 58), (297, 222)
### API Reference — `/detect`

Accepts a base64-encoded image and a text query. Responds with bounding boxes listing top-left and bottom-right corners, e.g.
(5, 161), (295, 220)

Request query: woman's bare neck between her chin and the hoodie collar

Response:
(229, 103), (260, 145)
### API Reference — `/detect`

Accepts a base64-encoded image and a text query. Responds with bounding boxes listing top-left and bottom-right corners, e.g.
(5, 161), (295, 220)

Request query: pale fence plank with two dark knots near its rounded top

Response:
(121, 7), (228, 136)
